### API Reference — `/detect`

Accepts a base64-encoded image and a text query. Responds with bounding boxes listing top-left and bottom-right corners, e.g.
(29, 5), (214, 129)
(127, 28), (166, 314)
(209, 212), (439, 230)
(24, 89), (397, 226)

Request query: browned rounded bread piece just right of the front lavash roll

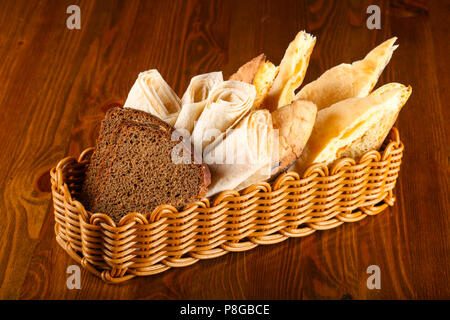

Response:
(272, 99), (317, 175)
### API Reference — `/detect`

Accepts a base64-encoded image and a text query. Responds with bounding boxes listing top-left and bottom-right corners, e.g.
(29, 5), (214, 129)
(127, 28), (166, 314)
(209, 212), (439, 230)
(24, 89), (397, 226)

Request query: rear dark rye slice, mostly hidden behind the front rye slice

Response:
(81, 107), (170, 210)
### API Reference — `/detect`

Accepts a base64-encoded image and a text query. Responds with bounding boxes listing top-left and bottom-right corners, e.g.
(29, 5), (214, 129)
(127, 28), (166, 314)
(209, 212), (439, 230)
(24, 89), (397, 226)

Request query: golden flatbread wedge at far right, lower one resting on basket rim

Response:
(294, 84), (411, 172)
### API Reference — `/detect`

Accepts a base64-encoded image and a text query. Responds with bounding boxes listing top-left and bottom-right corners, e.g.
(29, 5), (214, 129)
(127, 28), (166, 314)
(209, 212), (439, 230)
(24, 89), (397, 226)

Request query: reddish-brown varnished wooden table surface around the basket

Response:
(0, 0), (450, 299)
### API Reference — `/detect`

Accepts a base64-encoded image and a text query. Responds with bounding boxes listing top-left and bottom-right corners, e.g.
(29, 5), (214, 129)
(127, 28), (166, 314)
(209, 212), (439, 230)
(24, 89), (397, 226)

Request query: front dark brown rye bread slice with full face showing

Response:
(93, 121), (211, 222)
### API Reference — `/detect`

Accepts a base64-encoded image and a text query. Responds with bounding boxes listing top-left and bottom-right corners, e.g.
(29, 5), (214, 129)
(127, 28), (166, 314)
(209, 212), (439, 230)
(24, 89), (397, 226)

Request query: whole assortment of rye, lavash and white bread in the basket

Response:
(82, 31), (411, 219)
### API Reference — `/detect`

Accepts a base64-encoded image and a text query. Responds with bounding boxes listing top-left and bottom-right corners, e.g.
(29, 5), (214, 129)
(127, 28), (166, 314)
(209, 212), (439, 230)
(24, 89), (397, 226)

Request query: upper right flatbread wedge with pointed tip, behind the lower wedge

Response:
(295, 37), (398, 110)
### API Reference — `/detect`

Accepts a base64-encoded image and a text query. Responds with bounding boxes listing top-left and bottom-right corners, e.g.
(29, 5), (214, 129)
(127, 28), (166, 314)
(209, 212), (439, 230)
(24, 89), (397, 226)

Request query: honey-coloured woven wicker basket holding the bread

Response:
(50, 128), (403, 283)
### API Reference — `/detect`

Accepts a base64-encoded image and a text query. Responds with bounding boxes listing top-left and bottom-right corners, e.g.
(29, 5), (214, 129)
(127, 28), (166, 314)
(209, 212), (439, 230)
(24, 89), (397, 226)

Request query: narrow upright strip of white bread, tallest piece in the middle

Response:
(263, 31), (316, 111)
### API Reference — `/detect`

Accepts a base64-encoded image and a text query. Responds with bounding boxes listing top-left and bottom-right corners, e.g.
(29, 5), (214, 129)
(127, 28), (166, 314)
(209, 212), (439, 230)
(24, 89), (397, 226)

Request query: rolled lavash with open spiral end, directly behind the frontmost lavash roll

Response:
(191, 80), (256, 154)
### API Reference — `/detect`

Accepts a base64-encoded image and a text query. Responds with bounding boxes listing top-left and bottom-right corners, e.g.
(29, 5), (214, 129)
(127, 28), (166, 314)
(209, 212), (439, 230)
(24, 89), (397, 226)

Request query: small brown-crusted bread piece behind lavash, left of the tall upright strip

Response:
(230, 53), (280, 109)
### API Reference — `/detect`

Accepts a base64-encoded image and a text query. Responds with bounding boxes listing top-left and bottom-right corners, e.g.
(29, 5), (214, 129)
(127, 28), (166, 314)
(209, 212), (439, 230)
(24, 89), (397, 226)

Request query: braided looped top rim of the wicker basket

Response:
(50, 127), (404, 229)
